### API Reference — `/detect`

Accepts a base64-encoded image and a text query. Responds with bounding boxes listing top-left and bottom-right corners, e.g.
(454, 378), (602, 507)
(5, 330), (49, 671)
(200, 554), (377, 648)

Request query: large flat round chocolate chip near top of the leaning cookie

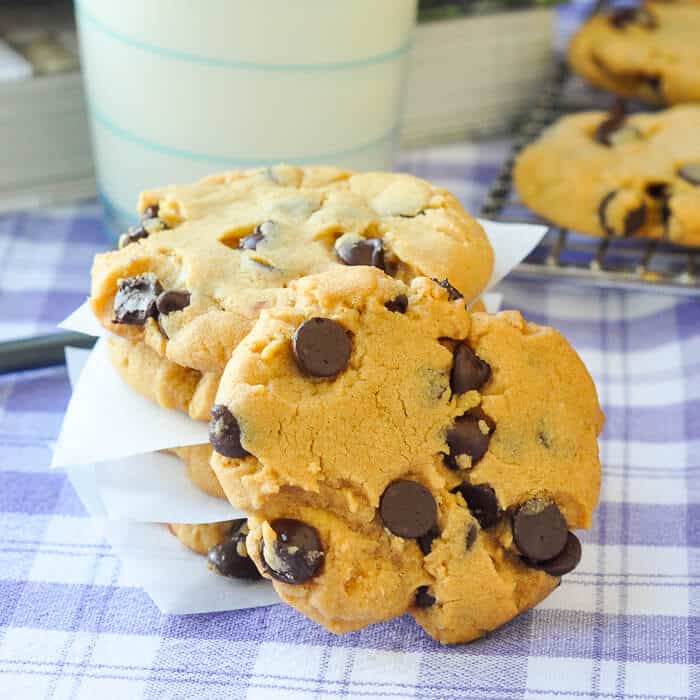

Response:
(292, 317), (352, 377)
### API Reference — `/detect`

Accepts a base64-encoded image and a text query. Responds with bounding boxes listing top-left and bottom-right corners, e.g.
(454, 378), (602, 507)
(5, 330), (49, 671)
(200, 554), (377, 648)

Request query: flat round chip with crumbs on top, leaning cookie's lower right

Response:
(513, 499), (568, 562)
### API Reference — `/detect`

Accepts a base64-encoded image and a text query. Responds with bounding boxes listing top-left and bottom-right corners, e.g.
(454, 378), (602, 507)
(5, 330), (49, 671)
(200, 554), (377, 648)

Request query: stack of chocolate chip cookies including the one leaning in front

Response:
(86, 166), (603, 642)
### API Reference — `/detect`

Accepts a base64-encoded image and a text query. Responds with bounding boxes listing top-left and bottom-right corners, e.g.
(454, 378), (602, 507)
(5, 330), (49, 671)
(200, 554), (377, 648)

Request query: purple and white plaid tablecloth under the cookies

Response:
(0, 143), (700, 700)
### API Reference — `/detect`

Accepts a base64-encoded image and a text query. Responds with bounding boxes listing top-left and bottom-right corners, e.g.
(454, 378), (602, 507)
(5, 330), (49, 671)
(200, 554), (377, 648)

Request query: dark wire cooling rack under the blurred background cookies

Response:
(481, 65), (700, 296)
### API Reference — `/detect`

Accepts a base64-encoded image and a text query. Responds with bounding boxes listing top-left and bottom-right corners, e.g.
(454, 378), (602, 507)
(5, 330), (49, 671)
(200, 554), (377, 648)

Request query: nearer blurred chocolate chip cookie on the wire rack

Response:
(514, 105), (700, 246)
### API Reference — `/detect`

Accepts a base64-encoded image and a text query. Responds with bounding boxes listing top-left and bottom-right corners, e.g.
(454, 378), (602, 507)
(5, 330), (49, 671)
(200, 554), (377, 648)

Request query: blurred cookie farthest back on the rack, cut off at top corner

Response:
(568, 0), (700, 105)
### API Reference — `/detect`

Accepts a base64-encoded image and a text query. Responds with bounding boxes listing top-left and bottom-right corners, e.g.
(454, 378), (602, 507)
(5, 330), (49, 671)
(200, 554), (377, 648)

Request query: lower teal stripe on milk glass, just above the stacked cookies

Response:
(88, 104), (398, 168)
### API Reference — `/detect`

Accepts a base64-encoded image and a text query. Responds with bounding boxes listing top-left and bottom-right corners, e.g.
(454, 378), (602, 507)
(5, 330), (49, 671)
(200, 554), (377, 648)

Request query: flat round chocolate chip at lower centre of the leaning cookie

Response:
(379, 479), (437, 538)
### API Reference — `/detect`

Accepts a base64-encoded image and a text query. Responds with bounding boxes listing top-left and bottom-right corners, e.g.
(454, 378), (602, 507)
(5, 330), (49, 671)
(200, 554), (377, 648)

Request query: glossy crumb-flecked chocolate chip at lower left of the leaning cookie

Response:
(260, 518), (323, 584)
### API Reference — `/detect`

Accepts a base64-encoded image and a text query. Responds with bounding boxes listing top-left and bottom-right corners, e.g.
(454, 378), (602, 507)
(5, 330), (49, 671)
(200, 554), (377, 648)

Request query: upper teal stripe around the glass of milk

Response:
(75, 0), (412, 73)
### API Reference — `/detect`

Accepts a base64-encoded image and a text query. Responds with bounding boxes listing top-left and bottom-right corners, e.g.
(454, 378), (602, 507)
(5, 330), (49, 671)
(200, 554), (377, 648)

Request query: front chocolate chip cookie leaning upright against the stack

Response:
(210, 267), (603, 642)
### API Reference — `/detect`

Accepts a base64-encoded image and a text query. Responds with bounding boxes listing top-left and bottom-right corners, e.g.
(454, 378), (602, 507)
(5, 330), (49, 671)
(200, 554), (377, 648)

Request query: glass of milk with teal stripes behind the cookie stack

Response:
(75, 0), (416, 238)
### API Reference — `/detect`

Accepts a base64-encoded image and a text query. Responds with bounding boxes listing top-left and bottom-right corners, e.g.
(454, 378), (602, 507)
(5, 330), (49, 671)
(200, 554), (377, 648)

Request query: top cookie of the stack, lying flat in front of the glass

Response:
(90, 166), (493, 373)
